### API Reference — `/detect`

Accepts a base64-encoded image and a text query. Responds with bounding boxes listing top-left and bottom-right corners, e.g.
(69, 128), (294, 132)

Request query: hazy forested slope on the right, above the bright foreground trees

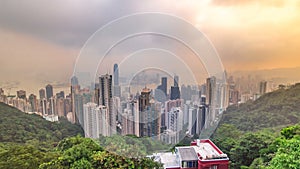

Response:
(220, 83), (300, 131)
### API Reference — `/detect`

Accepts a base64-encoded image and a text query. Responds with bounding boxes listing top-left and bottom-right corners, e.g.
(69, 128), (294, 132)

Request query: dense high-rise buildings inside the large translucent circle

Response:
(75, 64), (229, 144)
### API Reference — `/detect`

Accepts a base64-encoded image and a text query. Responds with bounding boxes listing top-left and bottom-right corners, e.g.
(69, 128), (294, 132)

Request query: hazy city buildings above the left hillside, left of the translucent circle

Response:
(0, 84), (74, 122)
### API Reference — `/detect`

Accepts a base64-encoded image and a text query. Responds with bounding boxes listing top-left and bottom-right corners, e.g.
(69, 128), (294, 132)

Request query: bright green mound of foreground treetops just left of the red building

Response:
(40, 137), (161, 169)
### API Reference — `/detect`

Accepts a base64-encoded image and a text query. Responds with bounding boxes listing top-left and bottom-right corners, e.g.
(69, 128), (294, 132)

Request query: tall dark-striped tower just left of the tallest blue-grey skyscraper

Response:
(99, 74), (116, 135)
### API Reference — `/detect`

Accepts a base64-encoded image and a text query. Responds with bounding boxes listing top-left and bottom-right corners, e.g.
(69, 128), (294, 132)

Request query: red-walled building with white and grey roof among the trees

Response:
(153, 139), (229, 169)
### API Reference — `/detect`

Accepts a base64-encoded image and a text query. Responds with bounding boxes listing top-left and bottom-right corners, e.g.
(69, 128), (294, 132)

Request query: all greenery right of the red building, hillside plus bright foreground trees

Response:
(212, 84), (300, 169)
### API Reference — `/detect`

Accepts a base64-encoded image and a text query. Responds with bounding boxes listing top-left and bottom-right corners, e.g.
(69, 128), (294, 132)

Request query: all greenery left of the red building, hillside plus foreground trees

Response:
(0, 103), (161, 169)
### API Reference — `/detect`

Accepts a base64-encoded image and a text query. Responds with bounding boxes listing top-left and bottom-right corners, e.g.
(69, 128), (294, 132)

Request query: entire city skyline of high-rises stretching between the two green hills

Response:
(0, 64), (274, 144)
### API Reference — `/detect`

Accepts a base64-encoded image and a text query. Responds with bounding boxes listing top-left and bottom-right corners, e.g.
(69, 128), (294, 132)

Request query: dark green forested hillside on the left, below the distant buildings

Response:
(0, 103), (83, 143)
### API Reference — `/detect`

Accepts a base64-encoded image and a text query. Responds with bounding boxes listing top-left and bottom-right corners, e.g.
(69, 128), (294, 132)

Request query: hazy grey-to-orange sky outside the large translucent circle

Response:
(0, 0), (300, 95)
